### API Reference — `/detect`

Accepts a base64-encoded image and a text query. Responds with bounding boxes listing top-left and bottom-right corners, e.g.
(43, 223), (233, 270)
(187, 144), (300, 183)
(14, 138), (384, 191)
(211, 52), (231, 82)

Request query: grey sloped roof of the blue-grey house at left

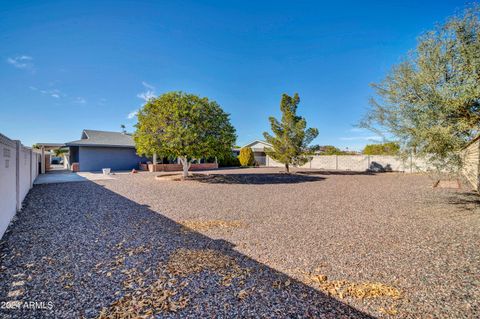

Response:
(65, 130), (135, 148)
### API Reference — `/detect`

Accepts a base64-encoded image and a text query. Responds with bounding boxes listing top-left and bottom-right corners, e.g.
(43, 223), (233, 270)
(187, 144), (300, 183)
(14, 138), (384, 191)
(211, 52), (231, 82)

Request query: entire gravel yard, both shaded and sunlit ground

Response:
(0, 168), (480, 318)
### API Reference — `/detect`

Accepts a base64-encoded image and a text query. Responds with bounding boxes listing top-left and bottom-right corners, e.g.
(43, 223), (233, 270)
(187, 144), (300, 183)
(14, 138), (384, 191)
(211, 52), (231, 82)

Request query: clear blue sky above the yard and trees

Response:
(0, 1), (465, 149)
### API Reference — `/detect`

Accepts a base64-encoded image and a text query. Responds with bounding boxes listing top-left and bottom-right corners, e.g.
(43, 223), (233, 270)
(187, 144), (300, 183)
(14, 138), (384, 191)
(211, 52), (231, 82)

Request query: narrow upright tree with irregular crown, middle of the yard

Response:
(263, 93), (318, 172)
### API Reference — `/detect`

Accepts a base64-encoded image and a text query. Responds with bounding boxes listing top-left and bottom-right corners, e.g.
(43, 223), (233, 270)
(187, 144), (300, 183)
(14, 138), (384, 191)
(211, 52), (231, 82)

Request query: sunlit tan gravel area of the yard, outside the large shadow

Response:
(103, 169), (480, 317)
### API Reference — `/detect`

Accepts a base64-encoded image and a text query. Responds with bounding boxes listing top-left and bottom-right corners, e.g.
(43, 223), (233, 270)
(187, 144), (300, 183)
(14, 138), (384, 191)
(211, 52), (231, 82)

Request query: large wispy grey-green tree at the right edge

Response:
(361, 7), (480, 170)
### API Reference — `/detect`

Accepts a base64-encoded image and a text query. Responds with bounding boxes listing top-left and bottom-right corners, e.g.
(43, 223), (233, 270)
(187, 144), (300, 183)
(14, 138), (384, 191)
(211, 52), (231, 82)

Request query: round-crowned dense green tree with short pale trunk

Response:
(133, 92), (236, 177)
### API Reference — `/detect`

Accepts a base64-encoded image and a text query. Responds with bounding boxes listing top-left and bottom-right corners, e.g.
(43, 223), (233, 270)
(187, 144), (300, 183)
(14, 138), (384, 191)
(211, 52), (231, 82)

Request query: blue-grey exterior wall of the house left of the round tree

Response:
(78, 146), (145, 172)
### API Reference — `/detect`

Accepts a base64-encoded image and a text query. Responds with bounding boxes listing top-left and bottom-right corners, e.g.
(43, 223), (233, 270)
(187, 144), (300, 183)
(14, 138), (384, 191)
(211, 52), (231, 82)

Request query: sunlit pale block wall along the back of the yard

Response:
(266, 155), (427, 173)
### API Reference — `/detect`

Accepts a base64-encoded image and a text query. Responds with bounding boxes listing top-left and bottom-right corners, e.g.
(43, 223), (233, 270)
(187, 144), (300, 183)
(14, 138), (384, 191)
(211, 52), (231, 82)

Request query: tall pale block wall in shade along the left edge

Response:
(0, 134), (40, 237)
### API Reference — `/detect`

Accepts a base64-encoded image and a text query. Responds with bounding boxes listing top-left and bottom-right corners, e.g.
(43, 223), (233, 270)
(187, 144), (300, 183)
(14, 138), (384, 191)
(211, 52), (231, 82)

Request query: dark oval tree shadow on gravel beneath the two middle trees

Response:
(192, 173), (325, 185)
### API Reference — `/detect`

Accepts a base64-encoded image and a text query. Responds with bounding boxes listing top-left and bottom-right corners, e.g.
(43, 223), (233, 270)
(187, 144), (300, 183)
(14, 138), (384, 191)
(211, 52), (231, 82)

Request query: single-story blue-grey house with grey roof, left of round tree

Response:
(65, 130), (146, 172)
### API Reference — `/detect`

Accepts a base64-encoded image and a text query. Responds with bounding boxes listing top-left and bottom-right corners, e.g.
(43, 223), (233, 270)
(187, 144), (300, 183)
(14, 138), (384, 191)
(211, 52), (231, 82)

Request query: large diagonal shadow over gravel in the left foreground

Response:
(0, 182), (372, 318)
